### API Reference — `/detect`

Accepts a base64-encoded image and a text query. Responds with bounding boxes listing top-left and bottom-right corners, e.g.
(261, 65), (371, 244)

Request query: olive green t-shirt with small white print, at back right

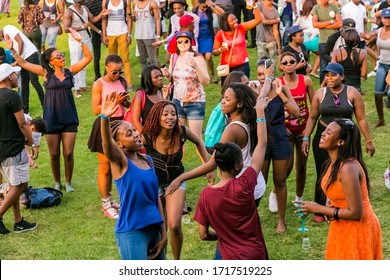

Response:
(311, 3), (340, 44)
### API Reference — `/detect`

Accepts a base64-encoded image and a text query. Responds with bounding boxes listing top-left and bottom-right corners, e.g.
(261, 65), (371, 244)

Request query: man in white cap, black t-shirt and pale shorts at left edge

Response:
(0, 63), (37, 235)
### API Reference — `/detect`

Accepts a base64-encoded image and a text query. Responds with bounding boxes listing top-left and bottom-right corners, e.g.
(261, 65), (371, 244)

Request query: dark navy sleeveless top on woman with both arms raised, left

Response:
(43, 69), (79, 134)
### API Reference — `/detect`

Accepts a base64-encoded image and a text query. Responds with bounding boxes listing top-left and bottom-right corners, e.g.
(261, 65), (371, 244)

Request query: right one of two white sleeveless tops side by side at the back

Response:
(134, 0), (156, 40)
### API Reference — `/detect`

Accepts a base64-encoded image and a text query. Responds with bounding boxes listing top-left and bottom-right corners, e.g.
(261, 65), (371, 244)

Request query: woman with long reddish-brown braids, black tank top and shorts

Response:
(142, 101), (212, 260)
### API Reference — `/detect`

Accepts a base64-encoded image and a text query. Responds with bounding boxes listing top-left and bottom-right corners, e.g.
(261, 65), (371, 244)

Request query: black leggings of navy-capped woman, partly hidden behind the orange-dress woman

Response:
(312, 122), (329, 205)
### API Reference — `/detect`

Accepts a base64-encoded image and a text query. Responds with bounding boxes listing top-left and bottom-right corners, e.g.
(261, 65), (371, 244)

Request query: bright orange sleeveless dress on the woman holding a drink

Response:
(321, 162), (382, 260)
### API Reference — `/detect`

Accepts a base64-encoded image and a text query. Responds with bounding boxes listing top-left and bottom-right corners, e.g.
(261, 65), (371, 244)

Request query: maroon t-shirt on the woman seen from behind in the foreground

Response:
(194, 167), (268, 260)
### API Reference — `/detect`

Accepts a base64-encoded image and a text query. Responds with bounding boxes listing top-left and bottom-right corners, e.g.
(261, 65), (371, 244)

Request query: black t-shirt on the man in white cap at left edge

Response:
(0, 88), (25, 162)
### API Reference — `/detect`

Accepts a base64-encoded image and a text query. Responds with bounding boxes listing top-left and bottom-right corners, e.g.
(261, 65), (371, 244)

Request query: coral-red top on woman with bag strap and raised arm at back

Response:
(215, 24), (249, 67)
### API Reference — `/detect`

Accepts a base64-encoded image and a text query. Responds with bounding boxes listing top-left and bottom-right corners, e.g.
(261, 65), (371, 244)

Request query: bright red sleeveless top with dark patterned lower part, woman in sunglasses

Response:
(279, 75), (309, 133)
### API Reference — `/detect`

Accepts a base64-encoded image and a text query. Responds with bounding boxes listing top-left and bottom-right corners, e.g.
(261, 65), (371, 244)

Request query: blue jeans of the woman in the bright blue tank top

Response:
(115, 226), (165, 260)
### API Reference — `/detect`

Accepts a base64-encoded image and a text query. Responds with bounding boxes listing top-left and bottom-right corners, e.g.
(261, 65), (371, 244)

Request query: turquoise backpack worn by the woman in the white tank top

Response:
(204, 102), (226, 154)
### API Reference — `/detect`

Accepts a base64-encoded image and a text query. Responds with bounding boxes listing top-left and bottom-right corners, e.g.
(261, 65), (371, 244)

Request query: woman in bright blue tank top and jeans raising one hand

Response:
(100, 93), (167, 260)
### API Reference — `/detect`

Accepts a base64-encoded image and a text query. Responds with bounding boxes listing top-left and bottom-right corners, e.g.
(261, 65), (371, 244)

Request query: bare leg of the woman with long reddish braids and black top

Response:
(165, 189), (185, 260)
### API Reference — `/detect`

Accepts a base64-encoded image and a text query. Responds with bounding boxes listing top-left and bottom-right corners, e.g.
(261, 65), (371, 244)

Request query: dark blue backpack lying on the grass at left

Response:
(27, 186), (63, 208)
